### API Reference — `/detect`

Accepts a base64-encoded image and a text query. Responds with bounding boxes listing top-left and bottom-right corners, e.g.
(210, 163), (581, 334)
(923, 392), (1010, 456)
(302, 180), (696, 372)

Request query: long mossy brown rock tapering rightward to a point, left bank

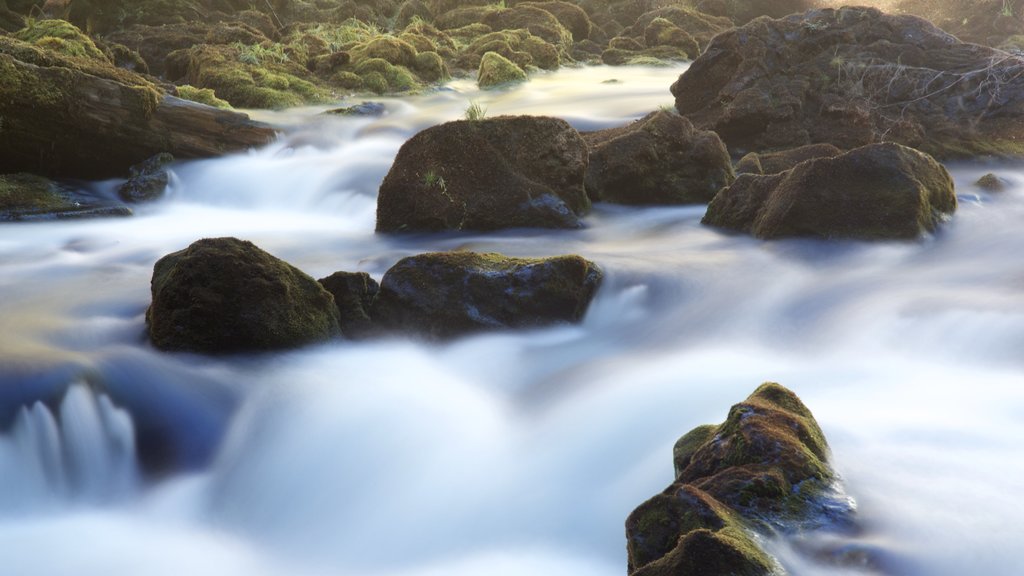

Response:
(0, 31), (273, 178)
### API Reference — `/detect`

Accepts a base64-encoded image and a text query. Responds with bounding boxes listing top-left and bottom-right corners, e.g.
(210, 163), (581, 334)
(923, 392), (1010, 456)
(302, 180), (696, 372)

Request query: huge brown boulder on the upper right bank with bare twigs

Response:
(672, 7), (1024, 157)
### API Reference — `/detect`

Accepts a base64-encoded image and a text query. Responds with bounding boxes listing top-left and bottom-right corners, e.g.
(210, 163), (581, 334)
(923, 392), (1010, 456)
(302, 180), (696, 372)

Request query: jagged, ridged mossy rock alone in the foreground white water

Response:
(626, 382), (853, 576)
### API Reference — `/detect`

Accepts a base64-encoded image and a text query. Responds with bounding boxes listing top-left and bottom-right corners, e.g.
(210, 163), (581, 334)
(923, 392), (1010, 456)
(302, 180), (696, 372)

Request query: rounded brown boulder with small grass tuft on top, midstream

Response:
(377, 116), (590, 232)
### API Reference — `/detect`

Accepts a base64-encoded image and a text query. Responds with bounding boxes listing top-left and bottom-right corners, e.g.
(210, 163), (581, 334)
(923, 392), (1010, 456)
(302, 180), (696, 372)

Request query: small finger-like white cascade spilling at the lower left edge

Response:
(0, 382), (138, 510)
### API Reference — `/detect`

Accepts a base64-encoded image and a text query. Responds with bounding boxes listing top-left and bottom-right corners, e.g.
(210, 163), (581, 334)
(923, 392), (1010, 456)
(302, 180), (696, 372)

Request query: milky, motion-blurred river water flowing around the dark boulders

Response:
(0, 69), (1024, 576)
